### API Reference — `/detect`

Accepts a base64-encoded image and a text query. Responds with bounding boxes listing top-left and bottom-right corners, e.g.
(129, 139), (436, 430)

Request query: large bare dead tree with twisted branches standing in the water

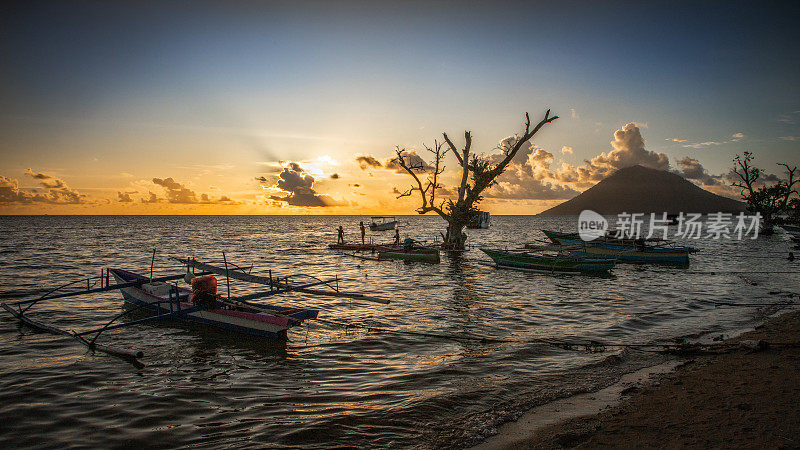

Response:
(392, 109), (558, 250)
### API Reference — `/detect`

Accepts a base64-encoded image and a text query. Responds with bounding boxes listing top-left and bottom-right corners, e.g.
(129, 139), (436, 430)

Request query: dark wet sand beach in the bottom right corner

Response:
(479, 311), (800, 448)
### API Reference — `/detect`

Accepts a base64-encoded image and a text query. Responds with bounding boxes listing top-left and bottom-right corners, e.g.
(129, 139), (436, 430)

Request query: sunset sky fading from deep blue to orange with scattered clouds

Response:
(0, 1), (800, 214)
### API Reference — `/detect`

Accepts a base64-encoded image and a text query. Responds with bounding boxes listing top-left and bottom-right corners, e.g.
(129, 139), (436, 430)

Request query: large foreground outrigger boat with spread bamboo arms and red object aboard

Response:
(0, 253), (389, 365)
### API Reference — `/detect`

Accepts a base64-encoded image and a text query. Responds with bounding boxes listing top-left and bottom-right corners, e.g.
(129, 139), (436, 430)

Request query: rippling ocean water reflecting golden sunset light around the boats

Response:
(0, 216), (800, 448)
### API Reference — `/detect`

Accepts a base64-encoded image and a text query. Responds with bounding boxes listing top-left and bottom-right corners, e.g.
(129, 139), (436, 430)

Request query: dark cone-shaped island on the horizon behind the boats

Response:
(540, 165), (746, 216)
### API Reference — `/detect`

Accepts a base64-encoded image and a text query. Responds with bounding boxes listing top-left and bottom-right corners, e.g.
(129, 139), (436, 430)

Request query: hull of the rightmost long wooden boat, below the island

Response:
(544, 231), (693, 265)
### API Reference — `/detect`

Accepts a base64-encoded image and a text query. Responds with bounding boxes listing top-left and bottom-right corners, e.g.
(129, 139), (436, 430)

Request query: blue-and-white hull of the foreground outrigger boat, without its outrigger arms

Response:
(110, 269), (299, 339)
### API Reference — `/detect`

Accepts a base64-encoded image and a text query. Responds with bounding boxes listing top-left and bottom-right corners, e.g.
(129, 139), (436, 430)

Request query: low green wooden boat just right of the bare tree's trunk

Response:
(481, 248), (616, 274)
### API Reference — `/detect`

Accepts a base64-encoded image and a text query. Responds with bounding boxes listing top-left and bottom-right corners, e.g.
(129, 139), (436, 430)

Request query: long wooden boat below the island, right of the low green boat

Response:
(542, 230), (697, 264)
